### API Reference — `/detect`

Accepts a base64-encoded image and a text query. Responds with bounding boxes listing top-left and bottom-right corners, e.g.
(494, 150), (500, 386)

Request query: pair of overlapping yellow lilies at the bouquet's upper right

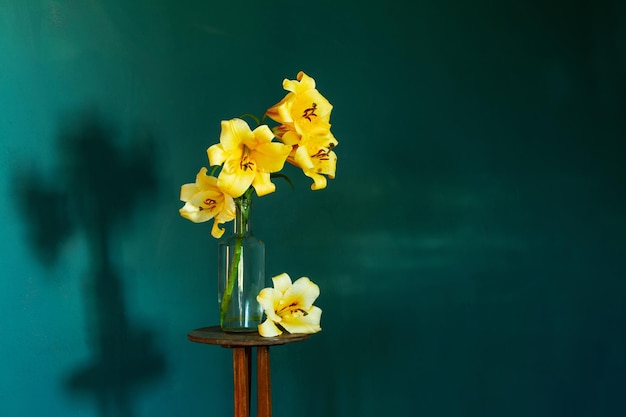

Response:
(266, 71), (338, 190)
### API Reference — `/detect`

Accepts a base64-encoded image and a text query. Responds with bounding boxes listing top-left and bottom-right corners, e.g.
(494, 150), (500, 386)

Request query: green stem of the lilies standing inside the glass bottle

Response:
(220, 187), (253, 326)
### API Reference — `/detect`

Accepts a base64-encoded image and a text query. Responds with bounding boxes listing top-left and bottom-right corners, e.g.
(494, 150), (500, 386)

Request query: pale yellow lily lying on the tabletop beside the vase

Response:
(257, 273), (322, 337)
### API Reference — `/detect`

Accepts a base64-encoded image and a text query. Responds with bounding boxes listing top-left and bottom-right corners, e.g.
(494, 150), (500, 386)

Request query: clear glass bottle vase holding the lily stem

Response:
(217, 193), (265, 332)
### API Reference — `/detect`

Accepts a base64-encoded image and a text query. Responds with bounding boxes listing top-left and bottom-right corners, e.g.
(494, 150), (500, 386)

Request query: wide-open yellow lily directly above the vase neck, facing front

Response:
(207, 118), (291, 198)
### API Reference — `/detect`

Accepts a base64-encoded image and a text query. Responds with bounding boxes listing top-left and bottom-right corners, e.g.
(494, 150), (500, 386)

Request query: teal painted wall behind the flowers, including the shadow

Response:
(0, 0), (626, 417)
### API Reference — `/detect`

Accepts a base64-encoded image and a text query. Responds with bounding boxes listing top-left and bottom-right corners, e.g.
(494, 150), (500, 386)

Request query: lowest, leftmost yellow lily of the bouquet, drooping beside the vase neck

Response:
(179, 168), (235, 238)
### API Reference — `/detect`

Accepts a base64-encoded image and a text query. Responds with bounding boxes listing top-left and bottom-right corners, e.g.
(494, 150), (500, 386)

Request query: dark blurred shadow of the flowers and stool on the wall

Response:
(17, 111), (165, 417)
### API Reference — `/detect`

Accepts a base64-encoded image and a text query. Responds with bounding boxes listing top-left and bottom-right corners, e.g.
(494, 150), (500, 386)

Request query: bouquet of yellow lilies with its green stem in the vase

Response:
(180, 72), (338, 336)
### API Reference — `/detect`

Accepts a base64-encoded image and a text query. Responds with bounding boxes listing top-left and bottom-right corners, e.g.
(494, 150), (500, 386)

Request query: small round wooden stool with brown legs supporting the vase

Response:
(187, 326), (309, 417)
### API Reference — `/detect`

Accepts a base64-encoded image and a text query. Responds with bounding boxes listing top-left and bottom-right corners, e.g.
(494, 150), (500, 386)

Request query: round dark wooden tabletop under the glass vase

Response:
(187, 326), (310, 348)
